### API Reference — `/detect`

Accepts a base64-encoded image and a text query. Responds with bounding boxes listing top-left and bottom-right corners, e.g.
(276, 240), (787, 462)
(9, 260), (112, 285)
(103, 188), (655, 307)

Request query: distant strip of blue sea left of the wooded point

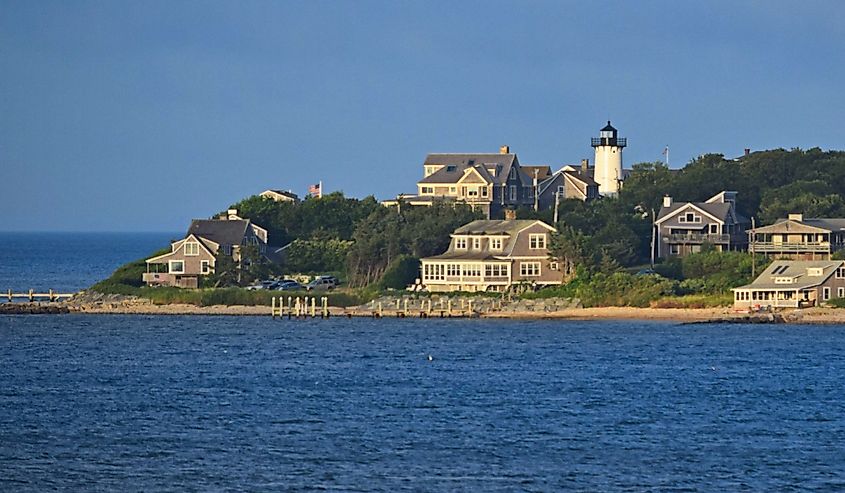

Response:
(0, 232), (180, 293)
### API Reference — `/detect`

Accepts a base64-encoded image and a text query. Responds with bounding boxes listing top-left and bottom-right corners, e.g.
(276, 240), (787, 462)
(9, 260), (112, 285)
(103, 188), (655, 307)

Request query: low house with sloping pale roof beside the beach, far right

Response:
(733, 260), (845, 308)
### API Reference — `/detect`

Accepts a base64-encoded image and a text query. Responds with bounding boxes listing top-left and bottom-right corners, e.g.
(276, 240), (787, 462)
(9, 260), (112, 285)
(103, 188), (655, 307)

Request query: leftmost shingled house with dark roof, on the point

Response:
(143, 210), (268, 288)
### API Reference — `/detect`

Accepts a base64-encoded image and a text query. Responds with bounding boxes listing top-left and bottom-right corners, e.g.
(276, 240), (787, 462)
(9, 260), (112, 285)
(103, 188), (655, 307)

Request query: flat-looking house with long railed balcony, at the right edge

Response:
(748, 214), (845, 260)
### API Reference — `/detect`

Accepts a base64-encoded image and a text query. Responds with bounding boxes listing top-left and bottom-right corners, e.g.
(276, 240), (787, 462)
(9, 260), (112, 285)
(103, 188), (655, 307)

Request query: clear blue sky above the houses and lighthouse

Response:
(0, 0), (845, 231)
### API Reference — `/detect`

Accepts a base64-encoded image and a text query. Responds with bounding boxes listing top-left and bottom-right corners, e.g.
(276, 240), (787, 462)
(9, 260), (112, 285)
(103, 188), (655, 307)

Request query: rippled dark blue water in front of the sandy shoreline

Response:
(0, 315), (845, 492)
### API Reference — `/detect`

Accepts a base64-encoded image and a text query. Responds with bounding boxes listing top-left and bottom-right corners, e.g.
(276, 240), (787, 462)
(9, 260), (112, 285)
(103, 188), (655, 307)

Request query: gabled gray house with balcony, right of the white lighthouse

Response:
(655, 191), (748, 257)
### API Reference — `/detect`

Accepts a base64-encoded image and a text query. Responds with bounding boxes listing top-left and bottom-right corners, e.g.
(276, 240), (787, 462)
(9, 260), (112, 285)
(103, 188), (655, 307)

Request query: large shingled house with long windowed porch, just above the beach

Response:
(421, 219), (563, 291)
